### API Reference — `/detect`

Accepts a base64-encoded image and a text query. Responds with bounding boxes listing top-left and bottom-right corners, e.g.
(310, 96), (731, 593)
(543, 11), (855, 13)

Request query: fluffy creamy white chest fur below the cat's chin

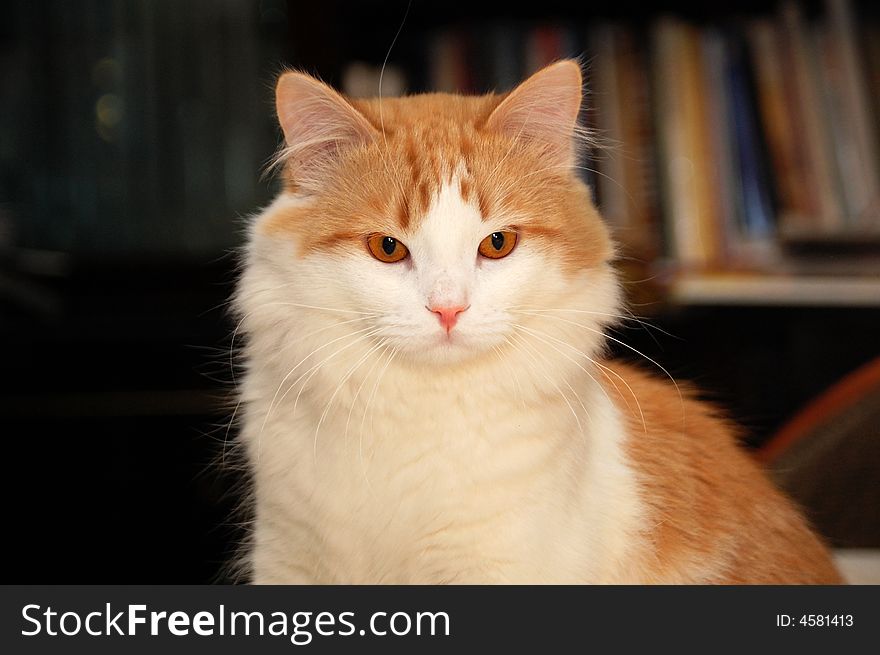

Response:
(243, 344), (639, 584)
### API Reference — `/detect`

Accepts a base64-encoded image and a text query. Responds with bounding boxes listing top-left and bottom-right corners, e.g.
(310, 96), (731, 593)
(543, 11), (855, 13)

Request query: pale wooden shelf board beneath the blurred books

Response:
(668, 274), (880, 307)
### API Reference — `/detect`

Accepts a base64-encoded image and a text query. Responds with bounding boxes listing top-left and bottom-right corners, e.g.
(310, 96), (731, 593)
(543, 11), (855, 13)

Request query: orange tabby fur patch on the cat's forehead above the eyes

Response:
(263, 94), (612, 274)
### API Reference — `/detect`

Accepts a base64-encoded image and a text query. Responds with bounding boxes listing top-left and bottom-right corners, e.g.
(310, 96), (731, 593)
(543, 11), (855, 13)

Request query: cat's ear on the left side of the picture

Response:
(275, 72), (376, 190)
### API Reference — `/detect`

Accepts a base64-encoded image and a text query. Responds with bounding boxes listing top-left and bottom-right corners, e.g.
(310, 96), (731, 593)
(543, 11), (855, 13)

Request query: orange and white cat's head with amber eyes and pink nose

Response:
(246, 61), (617, 372)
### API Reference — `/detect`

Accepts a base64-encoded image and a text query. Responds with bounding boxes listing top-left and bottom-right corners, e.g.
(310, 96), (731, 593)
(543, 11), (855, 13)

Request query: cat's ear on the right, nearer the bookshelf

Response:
(486, 59), (583, 167)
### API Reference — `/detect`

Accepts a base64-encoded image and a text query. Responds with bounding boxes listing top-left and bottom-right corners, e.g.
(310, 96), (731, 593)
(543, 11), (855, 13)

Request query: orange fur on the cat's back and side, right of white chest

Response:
(605, 362), (841, 584)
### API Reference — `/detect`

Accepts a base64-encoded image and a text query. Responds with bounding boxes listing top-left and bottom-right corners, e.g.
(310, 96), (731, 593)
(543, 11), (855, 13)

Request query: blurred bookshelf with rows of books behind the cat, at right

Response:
(330, 0), (880, 306)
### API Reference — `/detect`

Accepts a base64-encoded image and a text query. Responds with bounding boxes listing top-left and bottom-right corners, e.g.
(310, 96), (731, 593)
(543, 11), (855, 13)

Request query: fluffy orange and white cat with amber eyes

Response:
(234, 60), (840, 584)
